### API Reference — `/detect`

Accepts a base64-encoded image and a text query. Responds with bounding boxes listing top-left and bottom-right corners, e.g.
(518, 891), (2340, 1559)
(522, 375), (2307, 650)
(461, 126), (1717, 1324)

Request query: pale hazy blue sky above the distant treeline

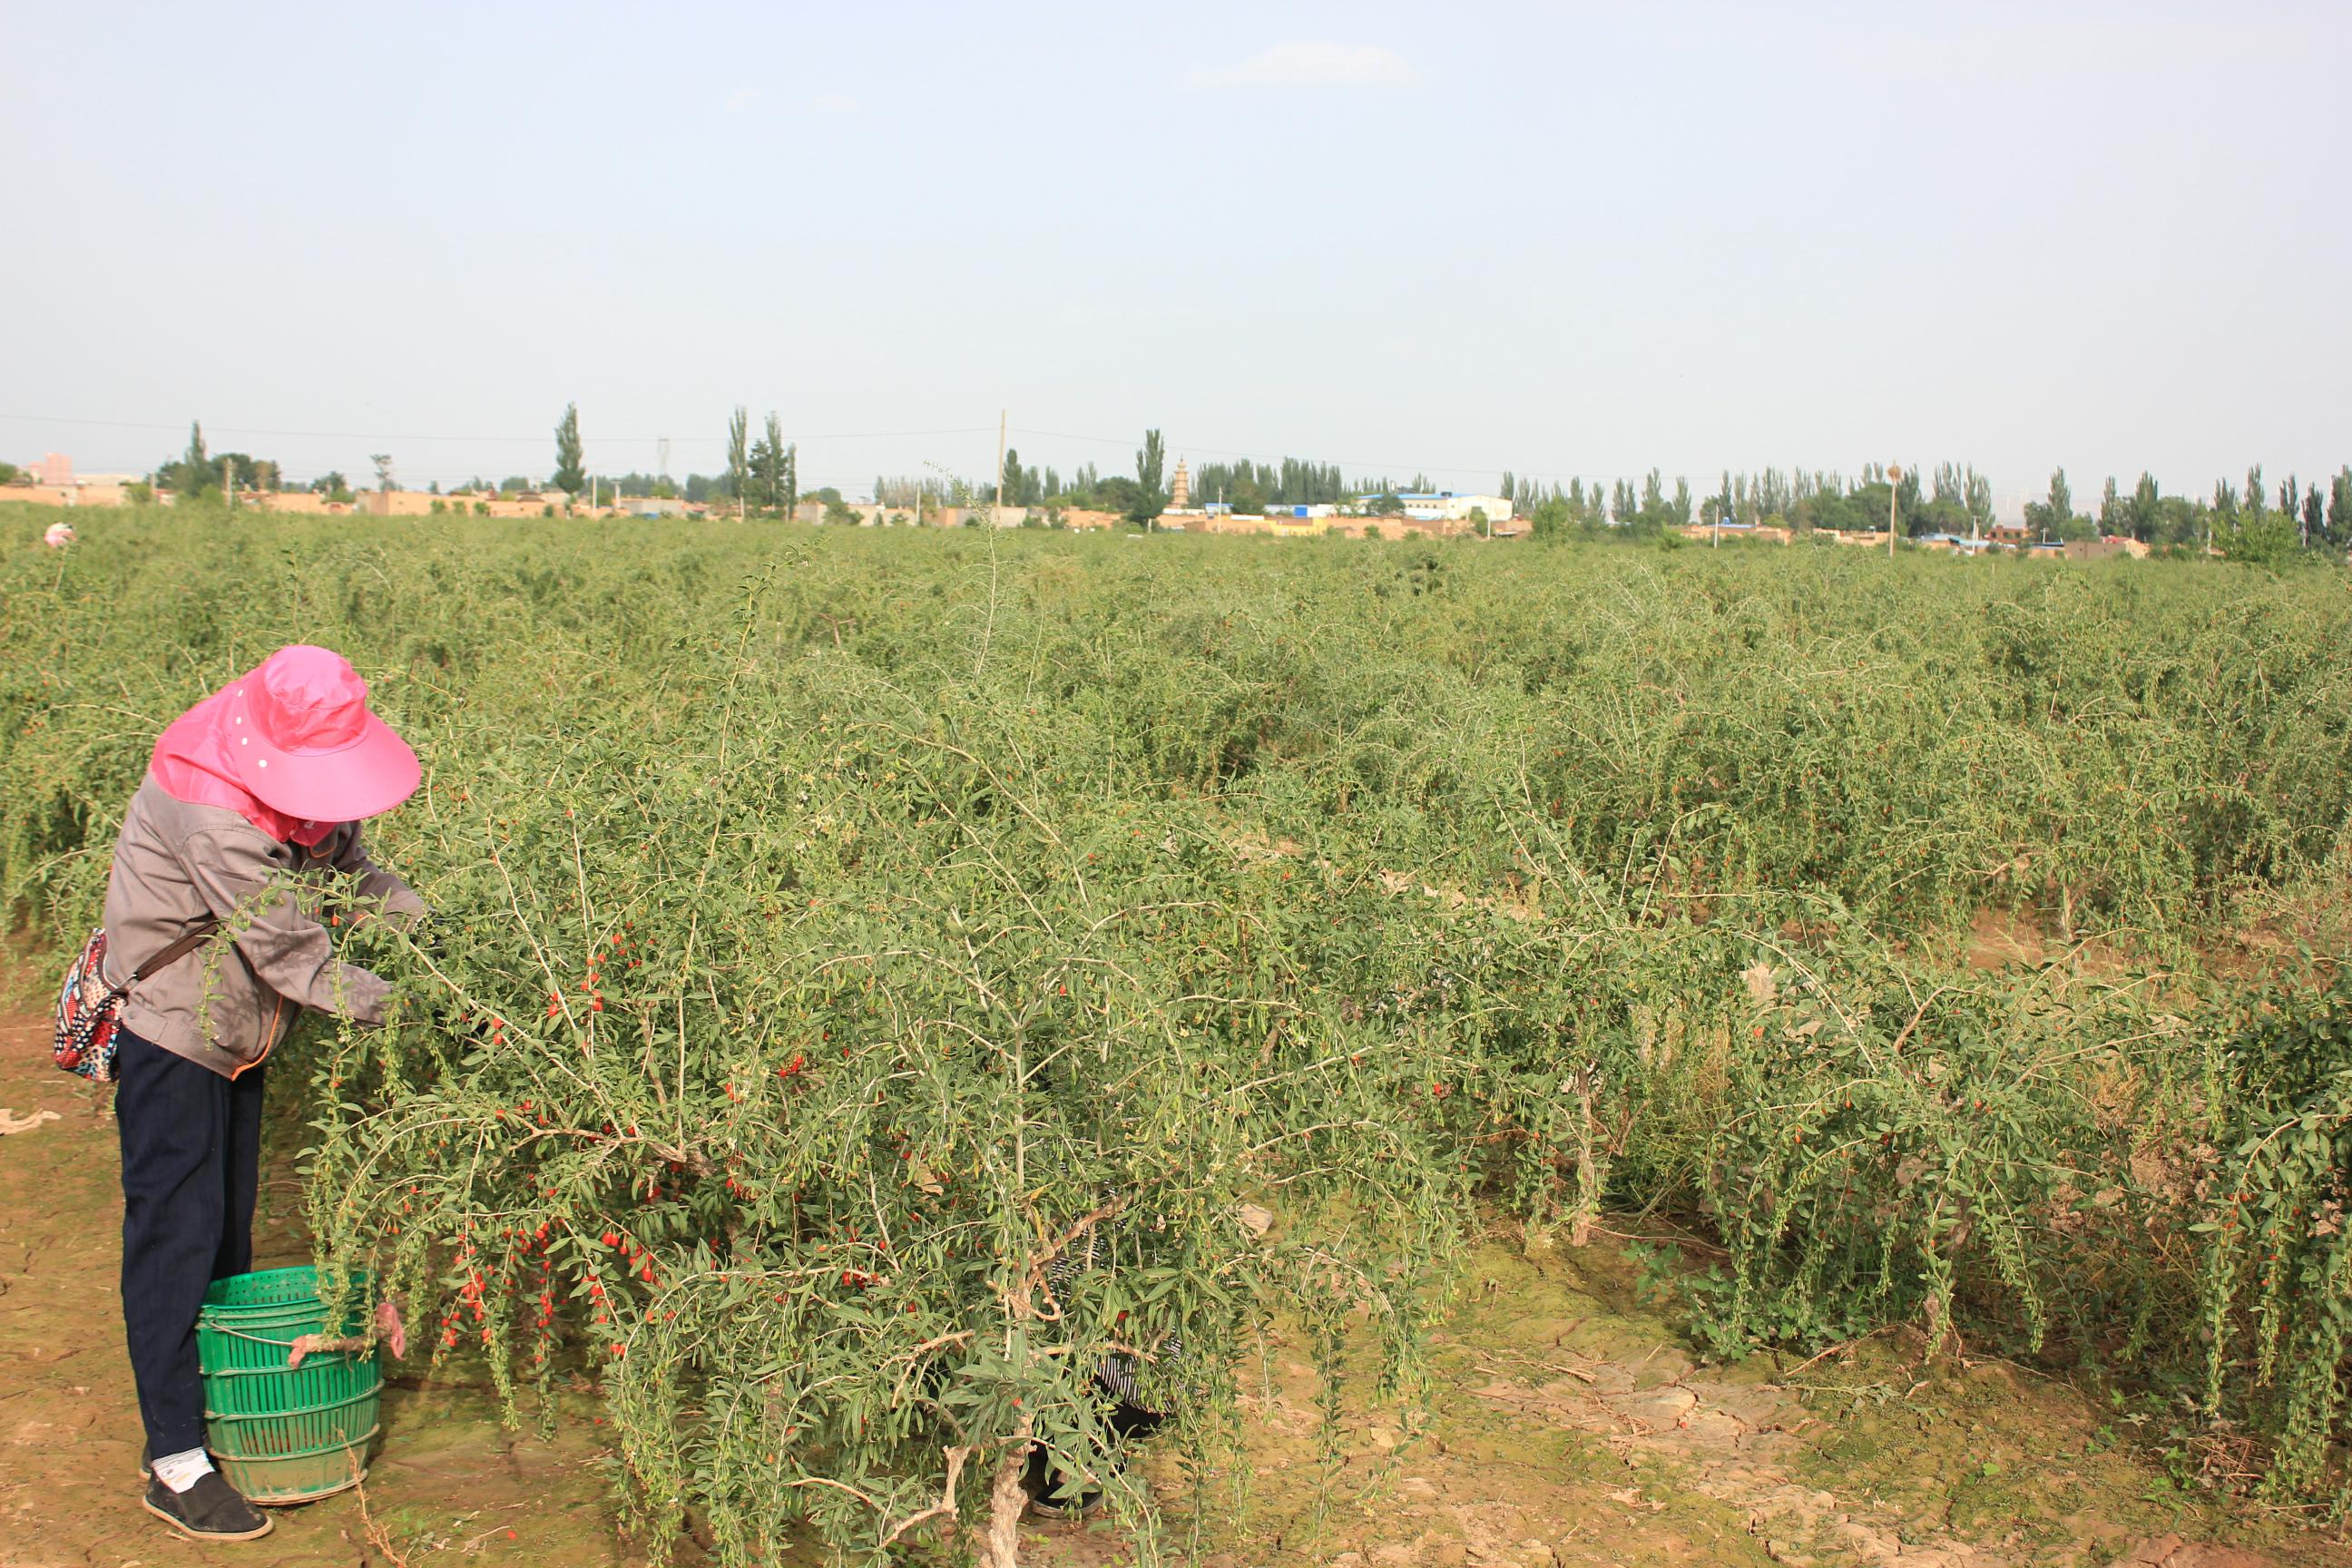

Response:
(0, 0), (2352, 510)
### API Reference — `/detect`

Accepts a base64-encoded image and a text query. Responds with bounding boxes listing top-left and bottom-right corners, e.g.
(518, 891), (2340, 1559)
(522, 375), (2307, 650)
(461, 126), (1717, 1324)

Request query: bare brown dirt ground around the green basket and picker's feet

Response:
(0, 1011), (642, 1568)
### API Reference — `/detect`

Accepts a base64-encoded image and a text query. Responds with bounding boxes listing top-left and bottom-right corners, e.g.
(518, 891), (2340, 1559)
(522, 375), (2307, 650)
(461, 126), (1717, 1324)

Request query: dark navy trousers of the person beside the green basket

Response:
(115, 1030), (263, 1453)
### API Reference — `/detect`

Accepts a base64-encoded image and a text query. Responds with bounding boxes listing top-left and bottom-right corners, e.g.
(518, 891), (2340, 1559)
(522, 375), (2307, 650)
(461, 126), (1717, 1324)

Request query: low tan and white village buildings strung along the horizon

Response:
(0, 451), (2150, 560)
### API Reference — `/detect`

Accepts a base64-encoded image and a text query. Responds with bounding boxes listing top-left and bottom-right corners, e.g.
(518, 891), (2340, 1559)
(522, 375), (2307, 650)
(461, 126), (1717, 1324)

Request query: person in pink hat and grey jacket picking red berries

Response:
(106, 644), (424, 1540)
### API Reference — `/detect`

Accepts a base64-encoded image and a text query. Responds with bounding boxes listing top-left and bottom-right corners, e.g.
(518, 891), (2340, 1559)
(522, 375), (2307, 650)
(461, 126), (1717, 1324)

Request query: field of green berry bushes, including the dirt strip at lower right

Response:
(0, 508), (2352, 1568)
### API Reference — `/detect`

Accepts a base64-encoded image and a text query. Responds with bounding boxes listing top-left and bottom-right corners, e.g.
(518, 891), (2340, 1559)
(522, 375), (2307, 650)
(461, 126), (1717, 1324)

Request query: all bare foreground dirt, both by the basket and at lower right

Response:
(0, 992), (2352, 1568)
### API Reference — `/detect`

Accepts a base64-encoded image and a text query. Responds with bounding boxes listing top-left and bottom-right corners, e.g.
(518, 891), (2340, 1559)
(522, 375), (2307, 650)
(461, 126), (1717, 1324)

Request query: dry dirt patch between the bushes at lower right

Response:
(1114, 1241), (2352, 1568)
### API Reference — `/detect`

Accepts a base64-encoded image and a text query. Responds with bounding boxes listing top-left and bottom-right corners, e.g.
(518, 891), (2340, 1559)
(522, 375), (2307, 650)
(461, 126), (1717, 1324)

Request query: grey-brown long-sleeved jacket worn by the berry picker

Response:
(106, 773), (424, 1079)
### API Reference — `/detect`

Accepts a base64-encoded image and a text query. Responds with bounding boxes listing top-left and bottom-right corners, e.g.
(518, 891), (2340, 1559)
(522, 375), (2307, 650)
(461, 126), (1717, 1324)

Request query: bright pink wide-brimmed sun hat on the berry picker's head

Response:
(223, 642), (424, 823)
